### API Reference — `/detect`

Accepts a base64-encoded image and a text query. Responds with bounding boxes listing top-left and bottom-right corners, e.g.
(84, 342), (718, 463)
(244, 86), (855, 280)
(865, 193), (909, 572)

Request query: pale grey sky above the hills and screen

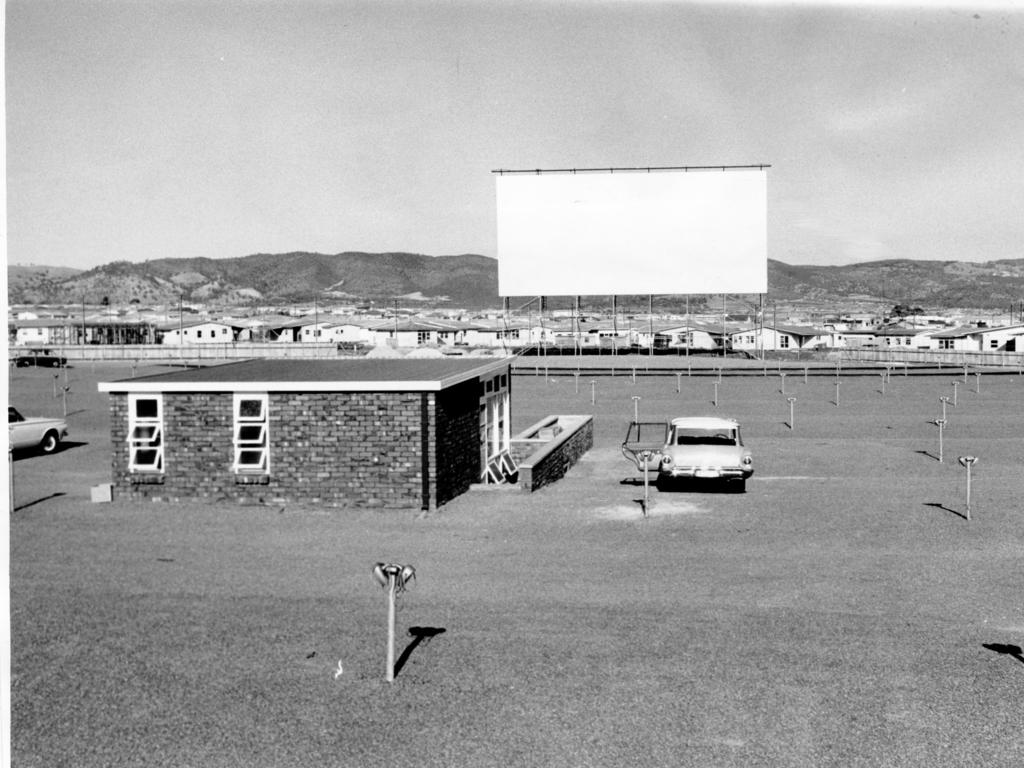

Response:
(5, 0), (1024, 268)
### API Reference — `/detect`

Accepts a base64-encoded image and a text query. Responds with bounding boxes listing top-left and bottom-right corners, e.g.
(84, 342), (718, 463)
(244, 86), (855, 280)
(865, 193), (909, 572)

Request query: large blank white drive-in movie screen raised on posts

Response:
(496, 168), (768, 296)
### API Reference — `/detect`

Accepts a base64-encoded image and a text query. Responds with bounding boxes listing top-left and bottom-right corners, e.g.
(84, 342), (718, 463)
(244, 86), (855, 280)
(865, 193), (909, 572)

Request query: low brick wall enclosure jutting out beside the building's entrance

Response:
(511, 416), (594, 492)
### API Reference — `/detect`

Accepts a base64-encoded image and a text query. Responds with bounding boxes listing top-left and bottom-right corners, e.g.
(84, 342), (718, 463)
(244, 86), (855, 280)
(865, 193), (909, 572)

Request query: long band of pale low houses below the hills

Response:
(11, 315), (1024, 352)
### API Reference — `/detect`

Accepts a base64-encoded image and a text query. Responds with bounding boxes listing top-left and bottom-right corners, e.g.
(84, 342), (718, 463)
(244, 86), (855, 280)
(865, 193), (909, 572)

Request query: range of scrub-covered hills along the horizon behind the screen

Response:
(8, 252), (1024, 309)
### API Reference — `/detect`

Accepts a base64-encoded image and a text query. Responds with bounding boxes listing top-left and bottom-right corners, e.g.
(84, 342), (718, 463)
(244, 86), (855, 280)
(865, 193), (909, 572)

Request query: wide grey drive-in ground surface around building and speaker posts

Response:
(10, 364), (1024, 767)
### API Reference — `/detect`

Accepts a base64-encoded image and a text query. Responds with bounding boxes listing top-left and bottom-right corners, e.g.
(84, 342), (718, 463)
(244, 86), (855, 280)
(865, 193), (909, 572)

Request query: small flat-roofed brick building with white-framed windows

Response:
(99, 359), (511, 509)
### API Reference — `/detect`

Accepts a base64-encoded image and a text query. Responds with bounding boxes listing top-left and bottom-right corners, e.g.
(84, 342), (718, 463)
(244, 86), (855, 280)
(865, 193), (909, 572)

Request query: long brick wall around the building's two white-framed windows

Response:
(111, 392), (436, 508)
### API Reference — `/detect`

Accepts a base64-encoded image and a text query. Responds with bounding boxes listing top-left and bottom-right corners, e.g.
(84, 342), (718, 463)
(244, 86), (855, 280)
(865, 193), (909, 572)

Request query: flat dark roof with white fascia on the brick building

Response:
(98, 357), (510, 392)
